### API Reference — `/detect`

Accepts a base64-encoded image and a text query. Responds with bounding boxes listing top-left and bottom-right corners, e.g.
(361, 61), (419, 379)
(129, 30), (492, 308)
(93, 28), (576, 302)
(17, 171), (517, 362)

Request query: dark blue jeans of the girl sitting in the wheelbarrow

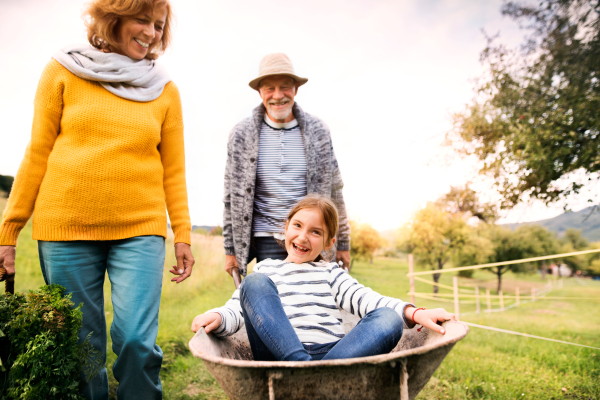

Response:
(240, 273), (404, 361)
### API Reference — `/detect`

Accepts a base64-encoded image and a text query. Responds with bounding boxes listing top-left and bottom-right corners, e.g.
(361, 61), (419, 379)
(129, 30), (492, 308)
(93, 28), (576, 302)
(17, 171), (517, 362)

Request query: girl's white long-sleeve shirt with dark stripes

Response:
(209, 259), (412, 344)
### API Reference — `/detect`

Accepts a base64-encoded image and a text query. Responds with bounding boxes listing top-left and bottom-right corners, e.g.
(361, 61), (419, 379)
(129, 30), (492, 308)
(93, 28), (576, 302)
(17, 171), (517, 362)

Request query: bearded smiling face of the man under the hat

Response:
(258, 75), (298, 123)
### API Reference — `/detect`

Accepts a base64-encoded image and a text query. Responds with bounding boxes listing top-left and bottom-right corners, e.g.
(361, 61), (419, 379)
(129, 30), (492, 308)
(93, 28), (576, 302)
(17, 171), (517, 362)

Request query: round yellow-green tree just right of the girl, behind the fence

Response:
(398, 203), (470, 293)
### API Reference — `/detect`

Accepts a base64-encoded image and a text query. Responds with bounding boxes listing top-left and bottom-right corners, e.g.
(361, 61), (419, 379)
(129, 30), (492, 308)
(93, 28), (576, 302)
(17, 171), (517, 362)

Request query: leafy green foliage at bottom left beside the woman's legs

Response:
(0, 285), (102, 400)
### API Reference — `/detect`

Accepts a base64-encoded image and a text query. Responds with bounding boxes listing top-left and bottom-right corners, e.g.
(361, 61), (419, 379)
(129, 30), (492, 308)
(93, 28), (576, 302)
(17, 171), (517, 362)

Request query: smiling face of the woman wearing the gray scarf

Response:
(117, 3), (167, 60)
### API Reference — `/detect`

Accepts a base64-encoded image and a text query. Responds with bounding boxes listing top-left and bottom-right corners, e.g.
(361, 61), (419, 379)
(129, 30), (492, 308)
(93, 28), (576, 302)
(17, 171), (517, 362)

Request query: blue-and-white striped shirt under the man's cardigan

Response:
(252, 114), (307, 236)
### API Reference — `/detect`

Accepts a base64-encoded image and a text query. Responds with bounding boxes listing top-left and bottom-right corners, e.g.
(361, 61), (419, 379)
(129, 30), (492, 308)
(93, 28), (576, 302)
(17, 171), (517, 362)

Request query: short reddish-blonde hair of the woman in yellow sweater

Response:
(83, 0), (172, 60)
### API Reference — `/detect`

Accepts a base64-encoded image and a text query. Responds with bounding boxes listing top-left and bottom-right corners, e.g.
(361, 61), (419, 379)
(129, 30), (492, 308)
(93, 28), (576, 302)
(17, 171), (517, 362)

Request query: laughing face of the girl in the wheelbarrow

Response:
(285, 208), (335, 264)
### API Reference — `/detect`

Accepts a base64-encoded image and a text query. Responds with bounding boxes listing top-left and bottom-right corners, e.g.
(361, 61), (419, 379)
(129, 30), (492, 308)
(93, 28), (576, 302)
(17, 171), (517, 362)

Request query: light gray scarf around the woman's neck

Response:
(52, 45), (171, 102)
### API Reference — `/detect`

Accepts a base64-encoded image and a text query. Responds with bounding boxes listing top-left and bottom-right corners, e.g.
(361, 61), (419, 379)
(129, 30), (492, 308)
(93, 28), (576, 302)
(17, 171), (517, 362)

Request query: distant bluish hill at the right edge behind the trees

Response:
(504, 206), (600, 242)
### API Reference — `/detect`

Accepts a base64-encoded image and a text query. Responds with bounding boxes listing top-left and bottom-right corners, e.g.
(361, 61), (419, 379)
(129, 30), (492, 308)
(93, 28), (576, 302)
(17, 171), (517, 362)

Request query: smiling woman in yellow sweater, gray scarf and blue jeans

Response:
(0, 0), (194, 399)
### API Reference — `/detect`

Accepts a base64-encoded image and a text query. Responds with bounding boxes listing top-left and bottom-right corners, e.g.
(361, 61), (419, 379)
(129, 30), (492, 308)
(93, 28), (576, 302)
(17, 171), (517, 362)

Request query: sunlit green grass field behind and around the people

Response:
(0, 199), (600, 399)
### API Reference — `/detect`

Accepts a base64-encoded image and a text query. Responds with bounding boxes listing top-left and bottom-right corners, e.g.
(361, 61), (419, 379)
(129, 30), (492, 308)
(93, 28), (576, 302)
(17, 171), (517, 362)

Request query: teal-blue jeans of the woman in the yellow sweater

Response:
(38, 236), (165, 400)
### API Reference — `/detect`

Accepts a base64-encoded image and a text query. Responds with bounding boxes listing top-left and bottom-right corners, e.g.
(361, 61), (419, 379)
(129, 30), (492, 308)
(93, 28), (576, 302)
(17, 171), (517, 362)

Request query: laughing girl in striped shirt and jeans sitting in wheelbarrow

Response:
(192, 195), (456, 361)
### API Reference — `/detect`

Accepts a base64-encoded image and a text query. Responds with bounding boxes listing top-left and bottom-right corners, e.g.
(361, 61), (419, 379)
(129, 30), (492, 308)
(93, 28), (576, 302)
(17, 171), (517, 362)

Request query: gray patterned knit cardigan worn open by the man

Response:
(223, 103), (350, 275)
